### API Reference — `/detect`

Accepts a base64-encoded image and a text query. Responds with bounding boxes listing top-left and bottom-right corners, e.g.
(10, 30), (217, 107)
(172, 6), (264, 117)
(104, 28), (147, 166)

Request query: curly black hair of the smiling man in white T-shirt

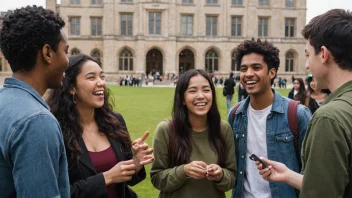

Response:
(236, 38), (280, 84)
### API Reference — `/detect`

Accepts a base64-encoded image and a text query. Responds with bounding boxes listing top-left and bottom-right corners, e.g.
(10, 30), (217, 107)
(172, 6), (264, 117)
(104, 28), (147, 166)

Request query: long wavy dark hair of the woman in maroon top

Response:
(47, 54), (131, 160)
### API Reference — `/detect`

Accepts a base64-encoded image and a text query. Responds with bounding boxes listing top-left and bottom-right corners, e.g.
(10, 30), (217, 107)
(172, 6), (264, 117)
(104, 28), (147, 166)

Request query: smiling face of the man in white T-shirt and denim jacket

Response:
(240, 53), (276, 95)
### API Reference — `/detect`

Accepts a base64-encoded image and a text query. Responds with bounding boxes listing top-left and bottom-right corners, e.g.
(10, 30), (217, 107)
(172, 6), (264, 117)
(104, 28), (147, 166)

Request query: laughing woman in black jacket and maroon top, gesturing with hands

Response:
(47, 54), (153, 198)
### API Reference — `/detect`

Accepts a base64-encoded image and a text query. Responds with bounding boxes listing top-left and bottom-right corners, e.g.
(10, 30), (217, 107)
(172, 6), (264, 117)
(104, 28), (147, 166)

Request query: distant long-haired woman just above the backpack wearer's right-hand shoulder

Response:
(288, 78), (309, 107)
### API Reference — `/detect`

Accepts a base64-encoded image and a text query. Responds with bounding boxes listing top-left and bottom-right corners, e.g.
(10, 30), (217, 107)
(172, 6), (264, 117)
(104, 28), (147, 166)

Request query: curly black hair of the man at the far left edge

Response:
(0, 5), (65, 72)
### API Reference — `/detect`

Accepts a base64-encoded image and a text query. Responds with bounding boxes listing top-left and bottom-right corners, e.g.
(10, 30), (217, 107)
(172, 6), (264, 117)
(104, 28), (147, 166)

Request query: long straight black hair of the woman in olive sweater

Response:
(170, 69), (228, 166)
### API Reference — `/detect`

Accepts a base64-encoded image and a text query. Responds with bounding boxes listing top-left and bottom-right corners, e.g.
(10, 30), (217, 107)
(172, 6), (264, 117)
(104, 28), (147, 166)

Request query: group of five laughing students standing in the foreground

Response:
(0, 6), (352, 198)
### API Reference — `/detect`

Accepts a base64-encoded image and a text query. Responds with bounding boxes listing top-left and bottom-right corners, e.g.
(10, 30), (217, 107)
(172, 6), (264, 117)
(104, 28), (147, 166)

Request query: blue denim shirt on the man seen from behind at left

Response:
(0, 78), (70, 198)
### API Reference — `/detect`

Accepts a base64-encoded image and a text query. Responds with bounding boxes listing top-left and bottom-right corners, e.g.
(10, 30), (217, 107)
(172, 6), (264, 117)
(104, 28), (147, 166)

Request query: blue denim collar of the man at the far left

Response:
(4, 78), (50, 110)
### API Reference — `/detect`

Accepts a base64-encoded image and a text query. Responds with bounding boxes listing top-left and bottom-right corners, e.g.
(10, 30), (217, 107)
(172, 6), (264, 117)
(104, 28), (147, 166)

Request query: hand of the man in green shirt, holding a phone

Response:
(255, 157), (290, 182)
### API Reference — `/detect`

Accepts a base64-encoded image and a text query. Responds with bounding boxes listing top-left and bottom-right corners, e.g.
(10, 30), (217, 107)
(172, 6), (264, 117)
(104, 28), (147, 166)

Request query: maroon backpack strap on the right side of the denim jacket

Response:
(287, 100), (302, 168)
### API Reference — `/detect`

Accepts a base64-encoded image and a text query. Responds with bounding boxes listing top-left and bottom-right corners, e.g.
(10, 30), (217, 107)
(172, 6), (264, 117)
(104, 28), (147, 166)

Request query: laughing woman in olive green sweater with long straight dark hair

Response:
(150, 69), (237, 198)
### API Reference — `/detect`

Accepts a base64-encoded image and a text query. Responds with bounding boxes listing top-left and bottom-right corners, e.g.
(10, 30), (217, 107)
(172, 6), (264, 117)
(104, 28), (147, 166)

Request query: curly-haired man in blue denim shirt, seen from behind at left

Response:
(0, 6), (70, 197)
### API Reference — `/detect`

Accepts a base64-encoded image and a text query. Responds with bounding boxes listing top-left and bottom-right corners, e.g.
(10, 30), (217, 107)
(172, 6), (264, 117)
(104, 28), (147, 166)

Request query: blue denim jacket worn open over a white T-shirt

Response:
(228, 89), (311, 198)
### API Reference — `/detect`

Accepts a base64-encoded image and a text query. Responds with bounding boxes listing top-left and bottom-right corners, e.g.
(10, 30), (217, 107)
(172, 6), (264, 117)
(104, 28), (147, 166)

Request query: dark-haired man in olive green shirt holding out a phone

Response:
(258, 9), (352, 198)
